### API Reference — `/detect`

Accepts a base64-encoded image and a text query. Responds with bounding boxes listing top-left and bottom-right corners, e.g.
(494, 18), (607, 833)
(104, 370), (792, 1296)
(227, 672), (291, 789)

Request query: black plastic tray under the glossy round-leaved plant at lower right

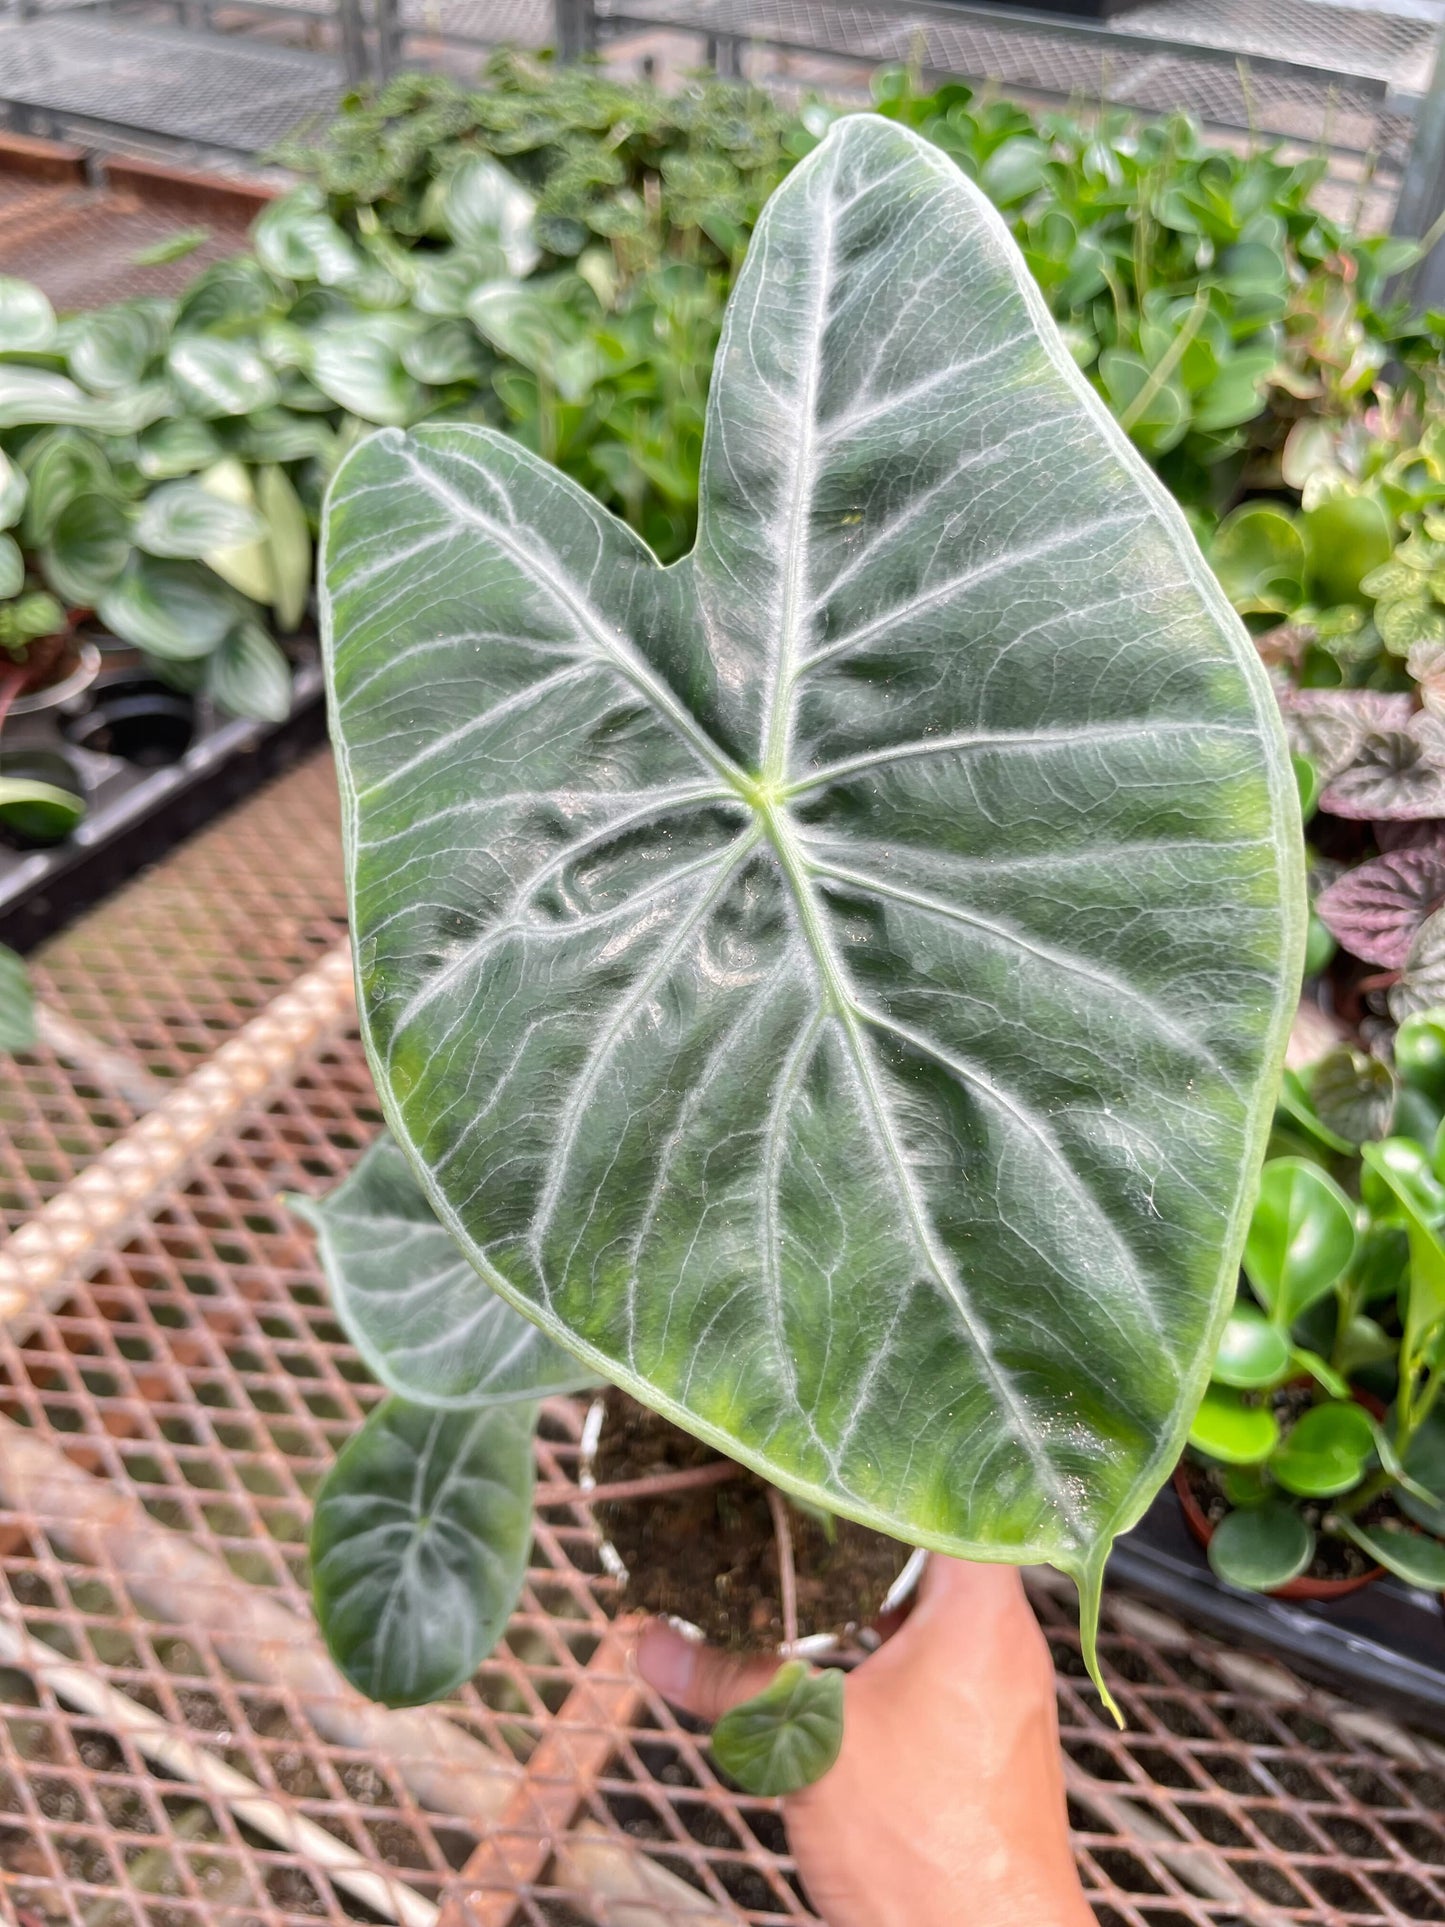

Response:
(1110, 1486), (1445, 1734)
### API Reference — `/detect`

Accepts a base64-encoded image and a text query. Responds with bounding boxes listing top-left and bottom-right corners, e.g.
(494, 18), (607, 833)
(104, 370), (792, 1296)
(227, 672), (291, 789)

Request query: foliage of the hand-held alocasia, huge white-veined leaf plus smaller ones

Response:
(302, 116), (1304, 1786)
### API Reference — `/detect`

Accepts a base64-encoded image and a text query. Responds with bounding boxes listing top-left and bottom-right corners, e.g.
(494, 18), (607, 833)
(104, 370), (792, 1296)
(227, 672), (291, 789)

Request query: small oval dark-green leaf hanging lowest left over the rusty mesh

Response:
(310, 1399), (536, 1705)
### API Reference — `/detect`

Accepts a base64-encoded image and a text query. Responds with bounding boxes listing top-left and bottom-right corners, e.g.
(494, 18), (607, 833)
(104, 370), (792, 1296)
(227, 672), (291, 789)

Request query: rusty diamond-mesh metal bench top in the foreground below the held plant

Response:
(0, 759), (1445, 1927)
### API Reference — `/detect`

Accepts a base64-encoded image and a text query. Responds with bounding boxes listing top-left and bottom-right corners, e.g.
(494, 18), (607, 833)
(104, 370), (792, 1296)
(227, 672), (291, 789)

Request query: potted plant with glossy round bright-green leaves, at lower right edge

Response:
(1175, 1012), (1445, 1599)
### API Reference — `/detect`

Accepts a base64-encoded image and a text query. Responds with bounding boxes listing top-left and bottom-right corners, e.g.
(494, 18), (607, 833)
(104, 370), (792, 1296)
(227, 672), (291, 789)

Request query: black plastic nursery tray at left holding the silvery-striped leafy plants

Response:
(0, 636), (326, 950)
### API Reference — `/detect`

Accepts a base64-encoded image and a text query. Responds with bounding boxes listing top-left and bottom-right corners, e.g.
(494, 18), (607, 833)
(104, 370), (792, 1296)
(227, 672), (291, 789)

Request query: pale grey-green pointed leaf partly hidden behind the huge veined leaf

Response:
(287, 1135), (597, 1405)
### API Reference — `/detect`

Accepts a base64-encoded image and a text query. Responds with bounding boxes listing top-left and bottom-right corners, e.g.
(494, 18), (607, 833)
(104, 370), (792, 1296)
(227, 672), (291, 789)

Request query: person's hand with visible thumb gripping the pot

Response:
(638, 1557), (1094, 1927)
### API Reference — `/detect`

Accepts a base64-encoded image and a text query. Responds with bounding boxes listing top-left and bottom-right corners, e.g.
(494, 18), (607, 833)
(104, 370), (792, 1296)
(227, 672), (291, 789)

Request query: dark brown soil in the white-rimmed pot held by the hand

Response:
(593, 1391), (909, 1650)
